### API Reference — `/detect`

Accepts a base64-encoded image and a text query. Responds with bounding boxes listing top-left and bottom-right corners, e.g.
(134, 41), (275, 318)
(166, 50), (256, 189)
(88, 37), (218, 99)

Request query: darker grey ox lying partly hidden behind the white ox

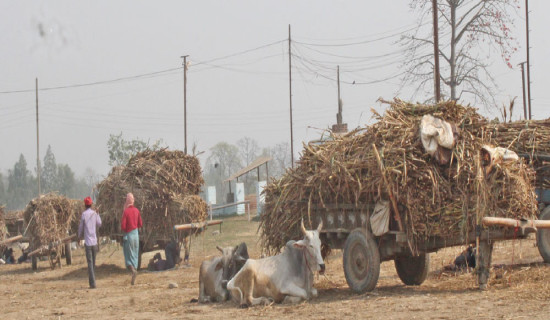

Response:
(191, 242), (248, 303)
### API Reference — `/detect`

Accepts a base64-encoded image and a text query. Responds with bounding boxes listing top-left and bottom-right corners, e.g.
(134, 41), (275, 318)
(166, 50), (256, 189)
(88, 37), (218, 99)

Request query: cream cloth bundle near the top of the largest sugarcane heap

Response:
(420, 114), (456, 164)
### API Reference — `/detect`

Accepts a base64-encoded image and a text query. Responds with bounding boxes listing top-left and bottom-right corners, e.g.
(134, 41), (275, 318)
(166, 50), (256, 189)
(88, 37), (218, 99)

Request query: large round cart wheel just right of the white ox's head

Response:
(344, 229), (380, 293)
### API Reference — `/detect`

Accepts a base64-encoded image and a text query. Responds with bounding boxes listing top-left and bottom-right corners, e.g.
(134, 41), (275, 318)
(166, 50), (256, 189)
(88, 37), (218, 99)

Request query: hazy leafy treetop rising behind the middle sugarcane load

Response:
(107, 132), (163, 166)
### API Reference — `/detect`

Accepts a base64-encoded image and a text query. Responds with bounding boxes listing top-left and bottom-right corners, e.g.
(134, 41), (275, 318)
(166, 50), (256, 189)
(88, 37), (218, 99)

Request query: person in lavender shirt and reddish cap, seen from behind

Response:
(78, 197), (101, 289)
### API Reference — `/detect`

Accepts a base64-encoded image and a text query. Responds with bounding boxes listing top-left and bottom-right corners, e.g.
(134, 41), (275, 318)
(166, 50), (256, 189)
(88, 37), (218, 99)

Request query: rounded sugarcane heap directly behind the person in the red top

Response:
(97, 149), (206, 245)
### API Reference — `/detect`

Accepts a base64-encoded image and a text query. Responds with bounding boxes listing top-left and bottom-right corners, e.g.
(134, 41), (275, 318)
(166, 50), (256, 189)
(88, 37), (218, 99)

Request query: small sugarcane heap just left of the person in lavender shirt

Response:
(24, 193), (75, 257)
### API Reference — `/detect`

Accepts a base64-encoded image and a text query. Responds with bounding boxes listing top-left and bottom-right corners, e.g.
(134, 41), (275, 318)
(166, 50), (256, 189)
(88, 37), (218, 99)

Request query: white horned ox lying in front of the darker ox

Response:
(227, 221), (325, 308)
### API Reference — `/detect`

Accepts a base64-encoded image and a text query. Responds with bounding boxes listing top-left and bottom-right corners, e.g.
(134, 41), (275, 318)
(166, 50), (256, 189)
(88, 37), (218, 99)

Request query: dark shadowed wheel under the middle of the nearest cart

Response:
(394, 253), (430, 286)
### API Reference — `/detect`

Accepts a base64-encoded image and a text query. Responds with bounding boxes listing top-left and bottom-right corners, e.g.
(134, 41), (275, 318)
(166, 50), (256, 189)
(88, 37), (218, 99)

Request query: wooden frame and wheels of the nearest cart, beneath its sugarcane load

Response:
(314, 200), (550, 293)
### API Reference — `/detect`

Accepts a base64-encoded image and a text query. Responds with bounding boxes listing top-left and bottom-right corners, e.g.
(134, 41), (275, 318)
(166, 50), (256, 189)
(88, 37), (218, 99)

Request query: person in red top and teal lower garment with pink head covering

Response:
(120, 193), (143, 285)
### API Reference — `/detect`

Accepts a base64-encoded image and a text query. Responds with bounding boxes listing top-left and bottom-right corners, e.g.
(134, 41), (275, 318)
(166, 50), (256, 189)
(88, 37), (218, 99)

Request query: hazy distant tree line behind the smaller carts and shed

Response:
(0, 133), (291, 210)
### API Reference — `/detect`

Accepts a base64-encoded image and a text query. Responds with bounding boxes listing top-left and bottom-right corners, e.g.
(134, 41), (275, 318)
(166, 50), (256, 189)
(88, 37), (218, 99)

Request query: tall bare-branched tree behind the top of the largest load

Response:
(401, 0), (517, 107)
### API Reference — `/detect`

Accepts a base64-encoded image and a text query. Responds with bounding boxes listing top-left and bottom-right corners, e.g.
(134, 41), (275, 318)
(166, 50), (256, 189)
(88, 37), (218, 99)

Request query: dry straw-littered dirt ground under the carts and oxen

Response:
(0, 218), (550, 319)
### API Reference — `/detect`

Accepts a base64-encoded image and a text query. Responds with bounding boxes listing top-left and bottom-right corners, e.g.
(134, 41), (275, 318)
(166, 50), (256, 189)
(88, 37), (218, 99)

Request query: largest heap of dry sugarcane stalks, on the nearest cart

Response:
(260, 100), (549, 252)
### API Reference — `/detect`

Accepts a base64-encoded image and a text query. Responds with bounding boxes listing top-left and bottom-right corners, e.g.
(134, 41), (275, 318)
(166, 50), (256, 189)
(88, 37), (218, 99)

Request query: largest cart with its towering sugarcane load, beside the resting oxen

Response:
(260, 99), (550, 292)
